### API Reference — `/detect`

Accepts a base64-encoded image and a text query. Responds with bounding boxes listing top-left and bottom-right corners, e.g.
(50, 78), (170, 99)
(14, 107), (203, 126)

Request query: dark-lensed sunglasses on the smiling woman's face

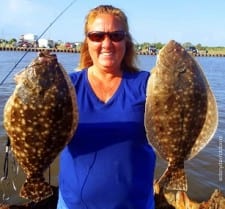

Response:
(87, 31), (127, 42)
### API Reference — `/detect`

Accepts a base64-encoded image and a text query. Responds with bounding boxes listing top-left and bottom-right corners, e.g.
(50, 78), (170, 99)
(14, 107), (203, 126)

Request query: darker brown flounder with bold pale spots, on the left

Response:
(4, 52), (78, 202)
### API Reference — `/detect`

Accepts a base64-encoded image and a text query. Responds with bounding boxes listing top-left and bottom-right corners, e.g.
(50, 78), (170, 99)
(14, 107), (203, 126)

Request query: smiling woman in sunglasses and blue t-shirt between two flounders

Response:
(58, 5), (155, 209)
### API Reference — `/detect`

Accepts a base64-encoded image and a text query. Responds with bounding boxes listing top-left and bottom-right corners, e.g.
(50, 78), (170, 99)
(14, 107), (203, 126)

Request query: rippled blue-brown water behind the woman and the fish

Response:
(0, 51), (225, 203)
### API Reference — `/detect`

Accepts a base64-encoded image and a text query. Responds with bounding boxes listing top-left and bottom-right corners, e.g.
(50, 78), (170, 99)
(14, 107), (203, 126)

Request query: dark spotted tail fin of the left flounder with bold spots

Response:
(20, 178), (53, 203)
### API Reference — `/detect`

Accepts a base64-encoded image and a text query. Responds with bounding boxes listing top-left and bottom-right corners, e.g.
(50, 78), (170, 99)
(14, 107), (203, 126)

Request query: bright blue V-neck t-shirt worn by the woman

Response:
(59, 69), (155, 209)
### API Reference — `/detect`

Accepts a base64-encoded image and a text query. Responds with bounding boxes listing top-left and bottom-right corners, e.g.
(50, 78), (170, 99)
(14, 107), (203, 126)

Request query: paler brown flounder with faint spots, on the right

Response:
(145, 40), (218, 191)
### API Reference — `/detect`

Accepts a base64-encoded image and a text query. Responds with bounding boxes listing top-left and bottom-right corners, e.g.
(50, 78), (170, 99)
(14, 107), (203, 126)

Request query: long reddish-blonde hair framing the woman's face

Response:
(78, 5), (139, 72)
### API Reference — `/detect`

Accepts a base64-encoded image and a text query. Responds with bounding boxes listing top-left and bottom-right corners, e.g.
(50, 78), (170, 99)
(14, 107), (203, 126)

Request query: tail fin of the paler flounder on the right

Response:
(157, 165), (188, 192)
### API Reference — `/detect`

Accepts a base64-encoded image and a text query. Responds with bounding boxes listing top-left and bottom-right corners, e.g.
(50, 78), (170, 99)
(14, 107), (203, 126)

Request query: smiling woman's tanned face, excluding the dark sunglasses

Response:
(87, 14), (126, 71)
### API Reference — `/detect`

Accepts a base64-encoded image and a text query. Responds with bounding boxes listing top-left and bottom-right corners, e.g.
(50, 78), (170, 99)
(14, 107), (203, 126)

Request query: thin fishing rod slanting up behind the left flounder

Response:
(0, 0), (77, 86)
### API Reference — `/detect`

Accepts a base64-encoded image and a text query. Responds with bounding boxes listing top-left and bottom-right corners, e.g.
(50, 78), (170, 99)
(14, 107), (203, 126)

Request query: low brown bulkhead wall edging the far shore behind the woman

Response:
(0, 47), (225, 57)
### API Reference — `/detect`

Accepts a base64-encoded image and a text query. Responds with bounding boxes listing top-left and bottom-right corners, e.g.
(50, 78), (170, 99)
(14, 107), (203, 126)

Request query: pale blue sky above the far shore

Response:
(0, 0), (225, 46)
